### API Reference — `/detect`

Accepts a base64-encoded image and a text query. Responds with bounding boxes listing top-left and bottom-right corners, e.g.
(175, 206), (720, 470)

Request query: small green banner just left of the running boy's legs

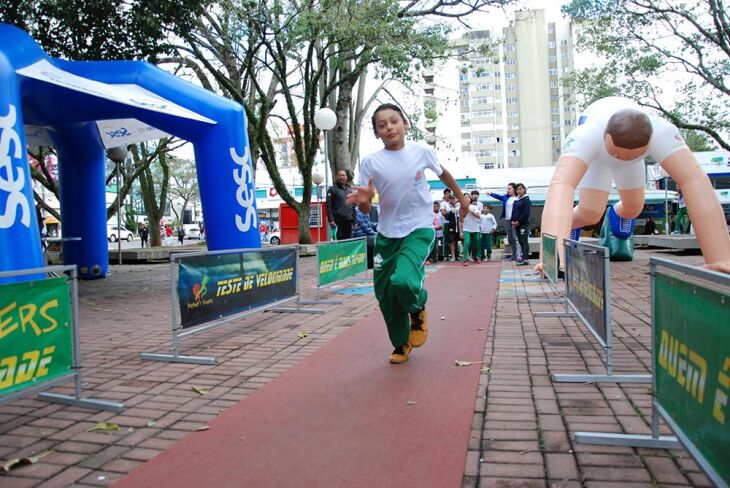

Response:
(317, 239), (368, 286)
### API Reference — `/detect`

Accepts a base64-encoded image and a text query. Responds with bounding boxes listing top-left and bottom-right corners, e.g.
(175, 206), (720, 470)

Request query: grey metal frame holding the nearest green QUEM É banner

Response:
(575, 257), (730, 488)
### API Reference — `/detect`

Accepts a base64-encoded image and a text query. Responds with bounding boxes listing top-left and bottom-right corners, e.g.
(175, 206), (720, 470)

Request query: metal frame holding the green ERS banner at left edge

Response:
(0, 265), (124, 413)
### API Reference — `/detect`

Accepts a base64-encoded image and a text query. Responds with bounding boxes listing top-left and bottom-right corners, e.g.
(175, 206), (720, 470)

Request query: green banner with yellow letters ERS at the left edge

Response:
(0, 277), (73, 397)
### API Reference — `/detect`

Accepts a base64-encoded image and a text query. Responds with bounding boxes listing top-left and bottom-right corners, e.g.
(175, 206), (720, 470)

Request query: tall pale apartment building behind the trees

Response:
(424, 10), (577, 169)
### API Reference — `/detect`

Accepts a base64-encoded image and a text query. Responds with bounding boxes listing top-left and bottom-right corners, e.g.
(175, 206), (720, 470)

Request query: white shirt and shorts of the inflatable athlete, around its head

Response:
(562, 97), (687, 191)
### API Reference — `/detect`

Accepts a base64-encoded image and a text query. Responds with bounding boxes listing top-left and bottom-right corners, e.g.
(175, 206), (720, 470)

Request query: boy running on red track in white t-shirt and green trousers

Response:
(347, 103), (469, 364)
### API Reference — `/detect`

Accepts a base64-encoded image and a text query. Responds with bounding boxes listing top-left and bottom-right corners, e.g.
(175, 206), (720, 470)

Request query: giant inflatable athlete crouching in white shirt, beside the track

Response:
(537, 97), (730, 273)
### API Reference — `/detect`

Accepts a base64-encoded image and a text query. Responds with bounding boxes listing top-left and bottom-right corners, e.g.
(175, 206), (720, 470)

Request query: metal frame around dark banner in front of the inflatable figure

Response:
(548, 239), (651, 383)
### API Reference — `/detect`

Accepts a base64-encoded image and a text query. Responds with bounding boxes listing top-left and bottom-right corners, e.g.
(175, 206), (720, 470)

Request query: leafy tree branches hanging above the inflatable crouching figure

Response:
(563, 0), (730, 149)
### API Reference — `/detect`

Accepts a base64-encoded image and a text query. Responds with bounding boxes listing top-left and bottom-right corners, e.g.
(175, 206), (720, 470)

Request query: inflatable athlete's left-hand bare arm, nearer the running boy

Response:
(537, 156), (588, 269)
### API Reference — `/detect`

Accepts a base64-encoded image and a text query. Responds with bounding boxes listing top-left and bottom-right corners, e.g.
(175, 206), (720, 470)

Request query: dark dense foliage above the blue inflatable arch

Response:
(0, 0), (208, 60)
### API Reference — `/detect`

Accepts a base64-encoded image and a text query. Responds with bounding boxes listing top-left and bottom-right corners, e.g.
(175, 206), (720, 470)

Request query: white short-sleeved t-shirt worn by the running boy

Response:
(360, 144), (443, 238)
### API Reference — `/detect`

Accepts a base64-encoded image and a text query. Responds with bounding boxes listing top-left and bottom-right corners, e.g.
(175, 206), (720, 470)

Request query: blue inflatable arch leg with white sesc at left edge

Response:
(0, 53), (43, 283)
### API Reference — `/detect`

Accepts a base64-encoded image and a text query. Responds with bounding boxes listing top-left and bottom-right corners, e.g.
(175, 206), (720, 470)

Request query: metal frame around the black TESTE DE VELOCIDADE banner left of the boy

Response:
(140, 244), (324, 364)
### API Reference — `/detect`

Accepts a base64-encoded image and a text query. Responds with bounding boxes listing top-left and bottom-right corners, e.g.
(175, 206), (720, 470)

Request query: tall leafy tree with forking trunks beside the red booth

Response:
(168, 0), (504, 243)
